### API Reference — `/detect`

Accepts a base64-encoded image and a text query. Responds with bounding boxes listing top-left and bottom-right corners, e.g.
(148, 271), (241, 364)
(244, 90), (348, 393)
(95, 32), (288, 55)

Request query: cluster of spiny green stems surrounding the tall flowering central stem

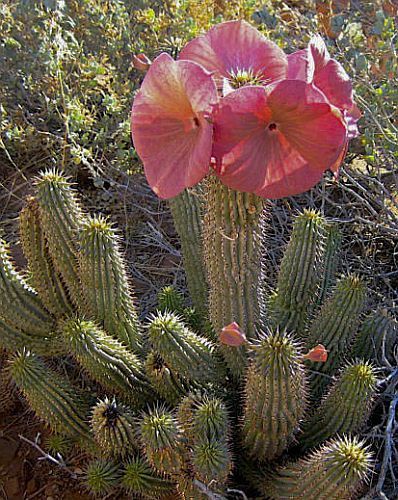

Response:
(0, 171), (396, 499)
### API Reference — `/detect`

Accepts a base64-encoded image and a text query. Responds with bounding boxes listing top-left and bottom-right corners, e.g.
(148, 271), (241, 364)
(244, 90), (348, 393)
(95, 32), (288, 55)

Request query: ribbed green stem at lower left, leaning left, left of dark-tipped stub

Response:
(9, 351), (91, 441)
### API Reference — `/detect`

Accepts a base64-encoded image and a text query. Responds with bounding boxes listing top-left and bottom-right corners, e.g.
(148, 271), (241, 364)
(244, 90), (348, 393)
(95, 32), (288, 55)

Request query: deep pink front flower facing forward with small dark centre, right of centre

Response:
(213, 80), (346, 198)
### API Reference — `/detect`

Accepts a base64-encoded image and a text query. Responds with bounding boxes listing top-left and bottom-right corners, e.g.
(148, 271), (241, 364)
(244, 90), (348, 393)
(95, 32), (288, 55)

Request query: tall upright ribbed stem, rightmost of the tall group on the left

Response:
(79, 217), (142, 352)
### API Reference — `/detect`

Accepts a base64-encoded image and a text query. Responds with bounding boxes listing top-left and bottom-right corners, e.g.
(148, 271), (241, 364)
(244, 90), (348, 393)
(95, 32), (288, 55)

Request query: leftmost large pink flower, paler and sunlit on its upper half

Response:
(131, 54), (217, 198)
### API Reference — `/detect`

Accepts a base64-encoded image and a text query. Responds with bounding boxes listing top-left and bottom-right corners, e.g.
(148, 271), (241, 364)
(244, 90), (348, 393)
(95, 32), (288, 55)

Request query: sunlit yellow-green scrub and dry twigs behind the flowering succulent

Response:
(0, 0), (398, 500)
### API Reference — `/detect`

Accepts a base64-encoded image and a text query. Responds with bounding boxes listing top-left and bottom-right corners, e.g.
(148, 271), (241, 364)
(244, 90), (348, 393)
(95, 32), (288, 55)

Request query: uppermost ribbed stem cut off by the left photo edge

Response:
(0, 239), (54, 337)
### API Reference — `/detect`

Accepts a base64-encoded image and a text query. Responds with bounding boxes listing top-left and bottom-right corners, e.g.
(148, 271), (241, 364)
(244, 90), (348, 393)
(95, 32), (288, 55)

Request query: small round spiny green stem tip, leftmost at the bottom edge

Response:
(85, 460), (120, 496)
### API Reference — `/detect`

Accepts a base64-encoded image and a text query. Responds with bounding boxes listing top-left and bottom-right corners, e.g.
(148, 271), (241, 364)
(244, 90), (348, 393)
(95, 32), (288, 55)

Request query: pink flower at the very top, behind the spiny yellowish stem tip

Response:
(179, 21), (287, 91)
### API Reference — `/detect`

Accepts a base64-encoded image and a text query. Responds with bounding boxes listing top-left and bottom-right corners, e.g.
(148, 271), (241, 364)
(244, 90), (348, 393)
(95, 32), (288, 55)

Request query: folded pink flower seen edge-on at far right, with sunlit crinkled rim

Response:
(287, 35), (361, 140)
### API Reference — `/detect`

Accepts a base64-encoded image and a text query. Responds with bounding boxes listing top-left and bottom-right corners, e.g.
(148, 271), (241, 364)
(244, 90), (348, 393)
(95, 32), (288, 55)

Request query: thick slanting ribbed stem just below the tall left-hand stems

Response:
(61, 320), (153, 404)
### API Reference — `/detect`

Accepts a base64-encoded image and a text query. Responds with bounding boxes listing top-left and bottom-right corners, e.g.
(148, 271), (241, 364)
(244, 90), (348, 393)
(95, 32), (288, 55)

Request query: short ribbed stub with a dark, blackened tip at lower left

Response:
(90, 398), (138, 457)
